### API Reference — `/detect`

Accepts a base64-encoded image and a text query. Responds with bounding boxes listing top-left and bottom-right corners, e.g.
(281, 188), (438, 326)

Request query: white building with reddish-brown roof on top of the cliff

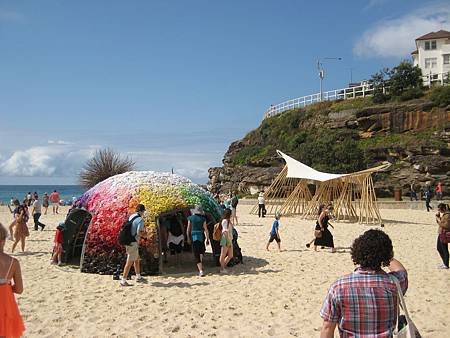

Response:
(411, 30), (450, 86)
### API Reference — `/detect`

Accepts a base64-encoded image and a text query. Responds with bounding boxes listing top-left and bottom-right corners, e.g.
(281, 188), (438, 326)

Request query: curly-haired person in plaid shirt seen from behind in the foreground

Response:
(320, 229), (408, 338)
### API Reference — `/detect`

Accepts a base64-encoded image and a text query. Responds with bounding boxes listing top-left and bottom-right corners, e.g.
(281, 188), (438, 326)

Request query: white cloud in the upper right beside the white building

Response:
(353, 2), (450, 58)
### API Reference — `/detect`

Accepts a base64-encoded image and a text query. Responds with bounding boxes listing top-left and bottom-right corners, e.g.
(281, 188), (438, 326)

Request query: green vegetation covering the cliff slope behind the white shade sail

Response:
(232, 98), (445, 173)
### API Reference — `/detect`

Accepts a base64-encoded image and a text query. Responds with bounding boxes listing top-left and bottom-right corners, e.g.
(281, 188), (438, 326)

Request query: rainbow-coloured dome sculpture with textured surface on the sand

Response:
(78, 171), (221, 274)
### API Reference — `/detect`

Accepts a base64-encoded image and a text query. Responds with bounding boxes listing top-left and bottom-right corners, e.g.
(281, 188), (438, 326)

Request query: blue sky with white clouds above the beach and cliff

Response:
(0, 0), (450, 184)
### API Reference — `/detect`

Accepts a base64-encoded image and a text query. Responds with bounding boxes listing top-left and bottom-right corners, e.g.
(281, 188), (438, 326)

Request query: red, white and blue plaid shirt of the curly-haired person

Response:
(320, 268), (408, 338)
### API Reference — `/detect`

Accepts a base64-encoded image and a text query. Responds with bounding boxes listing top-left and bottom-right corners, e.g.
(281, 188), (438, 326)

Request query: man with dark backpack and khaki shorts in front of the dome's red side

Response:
(120, 204), (145, 286)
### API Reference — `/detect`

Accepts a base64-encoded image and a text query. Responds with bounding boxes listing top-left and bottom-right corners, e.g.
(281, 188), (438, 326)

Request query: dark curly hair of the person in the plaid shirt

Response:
(351, 229), (394, 270)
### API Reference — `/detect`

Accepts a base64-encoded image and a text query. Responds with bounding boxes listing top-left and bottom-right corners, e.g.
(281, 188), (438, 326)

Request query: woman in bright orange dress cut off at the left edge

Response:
(0, 223), (25, 338)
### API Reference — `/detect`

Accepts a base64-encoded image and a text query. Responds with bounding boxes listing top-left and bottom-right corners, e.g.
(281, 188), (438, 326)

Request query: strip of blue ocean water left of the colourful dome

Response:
(0, 185), (86, 204)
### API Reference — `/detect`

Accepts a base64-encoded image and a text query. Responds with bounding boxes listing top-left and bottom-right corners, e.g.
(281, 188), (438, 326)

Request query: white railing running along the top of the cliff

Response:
(264, 73), (448, 119)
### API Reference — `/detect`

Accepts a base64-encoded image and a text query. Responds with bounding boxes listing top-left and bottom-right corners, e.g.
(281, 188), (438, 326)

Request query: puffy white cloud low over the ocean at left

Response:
(0, 144), (94, 177)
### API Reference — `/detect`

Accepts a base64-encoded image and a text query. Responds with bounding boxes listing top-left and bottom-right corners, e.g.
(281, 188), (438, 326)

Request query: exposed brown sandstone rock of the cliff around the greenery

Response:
(208, 100), (450, 197)
